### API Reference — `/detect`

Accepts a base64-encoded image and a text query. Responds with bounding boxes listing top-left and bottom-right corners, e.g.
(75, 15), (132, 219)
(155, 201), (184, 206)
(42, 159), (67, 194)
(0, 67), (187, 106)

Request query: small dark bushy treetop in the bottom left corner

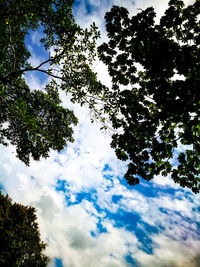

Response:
(0, 191), (48, 267)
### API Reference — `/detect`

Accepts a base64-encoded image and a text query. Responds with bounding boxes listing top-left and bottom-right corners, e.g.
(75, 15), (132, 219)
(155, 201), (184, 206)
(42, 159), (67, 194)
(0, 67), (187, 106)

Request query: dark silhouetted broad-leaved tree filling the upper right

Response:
(98, 0), (200, 193)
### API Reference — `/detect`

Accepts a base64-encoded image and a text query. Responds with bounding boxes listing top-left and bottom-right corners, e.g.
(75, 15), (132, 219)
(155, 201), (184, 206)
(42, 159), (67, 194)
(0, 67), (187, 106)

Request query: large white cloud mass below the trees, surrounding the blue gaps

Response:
(0, 105), (199, 267)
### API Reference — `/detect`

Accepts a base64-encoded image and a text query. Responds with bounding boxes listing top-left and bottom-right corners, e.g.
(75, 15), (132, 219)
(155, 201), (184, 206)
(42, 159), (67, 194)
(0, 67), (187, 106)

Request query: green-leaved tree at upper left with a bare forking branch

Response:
(0, 0), (102, 165)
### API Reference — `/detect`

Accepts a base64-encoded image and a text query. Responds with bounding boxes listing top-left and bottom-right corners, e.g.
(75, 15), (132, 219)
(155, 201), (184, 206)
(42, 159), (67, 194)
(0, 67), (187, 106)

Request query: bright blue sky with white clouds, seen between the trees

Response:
(0, 0), (200, 267)
